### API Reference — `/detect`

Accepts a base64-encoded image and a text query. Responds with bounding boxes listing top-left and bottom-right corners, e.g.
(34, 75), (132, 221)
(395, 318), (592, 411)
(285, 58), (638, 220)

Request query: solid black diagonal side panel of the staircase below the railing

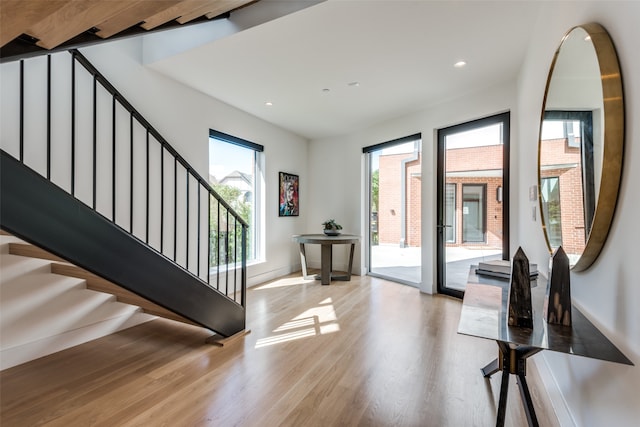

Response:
(0, 150), (245, 337)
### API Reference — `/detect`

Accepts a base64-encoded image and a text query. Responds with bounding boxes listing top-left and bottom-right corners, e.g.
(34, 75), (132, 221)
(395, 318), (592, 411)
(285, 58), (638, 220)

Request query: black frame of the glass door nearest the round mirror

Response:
(436, 111), (511, 298)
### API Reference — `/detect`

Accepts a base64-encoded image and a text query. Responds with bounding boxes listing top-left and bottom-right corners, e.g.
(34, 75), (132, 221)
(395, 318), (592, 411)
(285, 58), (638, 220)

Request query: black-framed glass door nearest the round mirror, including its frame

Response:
(437, 113), (509, 297)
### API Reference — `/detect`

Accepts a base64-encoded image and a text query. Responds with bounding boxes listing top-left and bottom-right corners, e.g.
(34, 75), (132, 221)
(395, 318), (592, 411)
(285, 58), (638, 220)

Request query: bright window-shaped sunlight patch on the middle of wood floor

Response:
(255, 298), (340, 348)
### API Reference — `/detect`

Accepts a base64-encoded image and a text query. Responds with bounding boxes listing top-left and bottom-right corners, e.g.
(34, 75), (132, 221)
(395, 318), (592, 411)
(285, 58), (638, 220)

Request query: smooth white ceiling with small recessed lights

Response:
(150, 0), (544, 139)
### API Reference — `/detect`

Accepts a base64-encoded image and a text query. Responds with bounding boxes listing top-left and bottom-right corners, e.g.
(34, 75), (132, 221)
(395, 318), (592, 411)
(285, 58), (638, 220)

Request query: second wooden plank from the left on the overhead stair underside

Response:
(26, 0), (138, 49)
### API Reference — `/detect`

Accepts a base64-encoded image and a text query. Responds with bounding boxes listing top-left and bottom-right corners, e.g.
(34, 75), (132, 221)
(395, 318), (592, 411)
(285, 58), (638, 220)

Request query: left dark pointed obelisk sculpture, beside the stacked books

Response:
(509, 248), (533, 328)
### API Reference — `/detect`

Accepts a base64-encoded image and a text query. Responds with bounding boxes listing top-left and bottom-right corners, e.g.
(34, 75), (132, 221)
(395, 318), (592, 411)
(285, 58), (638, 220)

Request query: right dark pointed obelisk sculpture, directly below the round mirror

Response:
(543, 246), (571, 326)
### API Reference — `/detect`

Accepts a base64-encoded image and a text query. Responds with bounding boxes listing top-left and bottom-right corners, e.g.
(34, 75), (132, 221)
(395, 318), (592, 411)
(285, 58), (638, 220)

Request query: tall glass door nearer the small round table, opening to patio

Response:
(363, 135), (422, 286)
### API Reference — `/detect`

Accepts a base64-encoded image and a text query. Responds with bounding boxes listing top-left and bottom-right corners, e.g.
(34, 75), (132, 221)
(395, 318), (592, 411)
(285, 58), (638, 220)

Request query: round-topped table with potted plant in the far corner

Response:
(292, 234), (360, 285)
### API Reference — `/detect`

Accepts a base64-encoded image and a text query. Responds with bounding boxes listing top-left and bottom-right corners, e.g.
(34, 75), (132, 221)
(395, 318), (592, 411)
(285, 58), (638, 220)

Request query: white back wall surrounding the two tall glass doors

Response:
(306, 82), (518, 294)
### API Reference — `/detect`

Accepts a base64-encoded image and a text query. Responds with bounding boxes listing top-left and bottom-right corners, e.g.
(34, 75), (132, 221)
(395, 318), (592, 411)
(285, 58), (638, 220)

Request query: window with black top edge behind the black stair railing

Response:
(209, 130), (264, 261)
